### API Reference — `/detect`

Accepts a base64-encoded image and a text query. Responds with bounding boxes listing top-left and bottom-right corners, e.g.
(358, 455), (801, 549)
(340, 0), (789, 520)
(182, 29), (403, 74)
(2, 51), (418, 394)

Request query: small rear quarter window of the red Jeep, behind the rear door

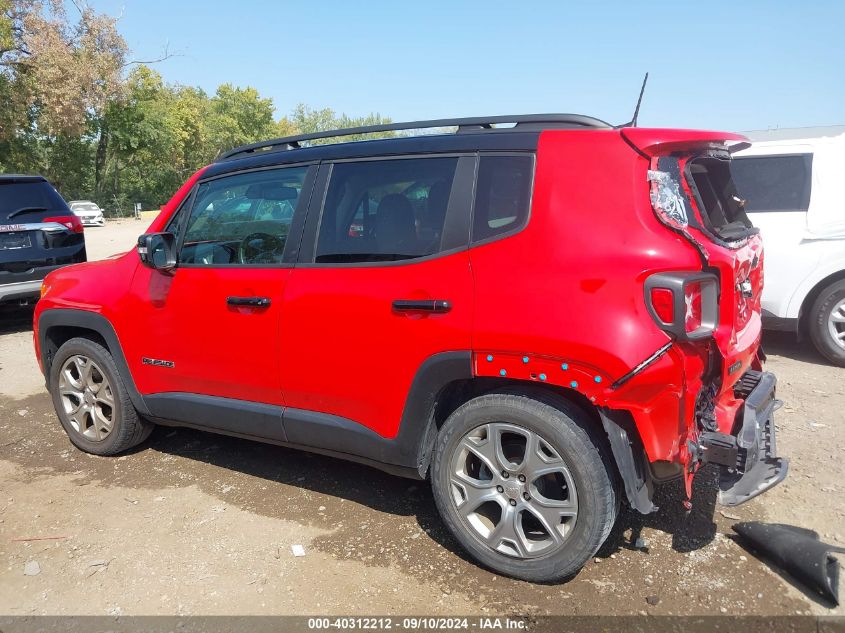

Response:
(472, 156), (534, 242)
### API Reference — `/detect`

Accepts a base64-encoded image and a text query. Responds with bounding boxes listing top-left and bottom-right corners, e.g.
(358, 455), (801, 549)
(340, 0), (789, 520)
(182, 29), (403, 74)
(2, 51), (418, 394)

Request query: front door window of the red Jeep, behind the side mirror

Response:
(179, 167), (308, 266)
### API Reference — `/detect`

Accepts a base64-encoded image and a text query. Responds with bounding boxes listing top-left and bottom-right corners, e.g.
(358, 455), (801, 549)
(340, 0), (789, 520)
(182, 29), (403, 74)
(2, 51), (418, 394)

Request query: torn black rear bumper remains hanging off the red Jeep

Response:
(699, 371), (789, 506)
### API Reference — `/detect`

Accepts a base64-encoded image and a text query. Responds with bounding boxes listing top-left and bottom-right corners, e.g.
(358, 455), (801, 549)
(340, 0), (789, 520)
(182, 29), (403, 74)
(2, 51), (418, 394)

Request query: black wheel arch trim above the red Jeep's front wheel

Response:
(38, 308), (150, 415)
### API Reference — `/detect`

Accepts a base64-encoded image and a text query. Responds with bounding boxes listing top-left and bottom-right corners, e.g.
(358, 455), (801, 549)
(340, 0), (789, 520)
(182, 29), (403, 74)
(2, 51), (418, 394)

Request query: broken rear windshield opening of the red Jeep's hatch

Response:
(686, 155), (756, 242)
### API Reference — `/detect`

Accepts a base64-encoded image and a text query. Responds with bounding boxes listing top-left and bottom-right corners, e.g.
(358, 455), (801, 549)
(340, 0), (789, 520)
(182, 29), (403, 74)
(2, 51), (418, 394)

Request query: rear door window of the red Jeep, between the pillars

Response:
(316, 158), (458, 263)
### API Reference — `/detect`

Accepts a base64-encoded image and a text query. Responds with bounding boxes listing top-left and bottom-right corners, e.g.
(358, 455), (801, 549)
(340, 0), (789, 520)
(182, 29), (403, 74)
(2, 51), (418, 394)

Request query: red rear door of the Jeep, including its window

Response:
(280, 155), (476, 442)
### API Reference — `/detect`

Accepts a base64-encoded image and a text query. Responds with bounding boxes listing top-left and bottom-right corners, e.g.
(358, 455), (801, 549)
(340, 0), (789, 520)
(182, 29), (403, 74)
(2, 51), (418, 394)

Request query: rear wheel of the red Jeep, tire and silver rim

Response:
(431, 393), (618, 582)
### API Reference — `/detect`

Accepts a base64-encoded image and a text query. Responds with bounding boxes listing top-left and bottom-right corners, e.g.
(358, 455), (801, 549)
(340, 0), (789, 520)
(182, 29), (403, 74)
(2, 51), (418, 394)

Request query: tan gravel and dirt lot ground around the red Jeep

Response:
(0, 220), (845, 615)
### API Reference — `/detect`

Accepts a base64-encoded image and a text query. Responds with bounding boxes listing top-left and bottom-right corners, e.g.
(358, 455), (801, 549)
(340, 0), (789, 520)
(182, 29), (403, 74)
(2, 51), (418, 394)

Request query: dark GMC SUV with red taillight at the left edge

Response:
(0, 176), (85, 285)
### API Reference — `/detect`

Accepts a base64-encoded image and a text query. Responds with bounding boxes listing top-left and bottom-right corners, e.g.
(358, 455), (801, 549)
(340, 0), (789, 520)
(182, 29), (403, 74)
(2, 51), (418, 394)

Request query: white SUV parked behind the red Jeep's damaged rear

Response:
(731, 126), (845, 366)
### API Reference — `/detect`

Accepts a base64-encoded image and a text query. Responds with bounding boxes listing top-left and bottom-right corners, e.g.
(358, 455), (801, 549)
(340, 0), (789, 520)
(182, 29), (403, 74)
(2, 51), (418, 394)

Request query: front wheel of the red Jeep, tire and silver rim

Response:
(50, 338), (153, 455)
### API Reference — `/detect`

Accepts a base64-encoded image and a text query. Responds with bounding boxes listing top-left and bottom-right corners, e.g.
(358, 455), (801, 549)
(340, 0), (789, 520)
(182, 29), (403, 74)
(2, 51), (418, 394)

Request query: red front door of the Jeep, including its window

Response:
(129, 166), (316, 406)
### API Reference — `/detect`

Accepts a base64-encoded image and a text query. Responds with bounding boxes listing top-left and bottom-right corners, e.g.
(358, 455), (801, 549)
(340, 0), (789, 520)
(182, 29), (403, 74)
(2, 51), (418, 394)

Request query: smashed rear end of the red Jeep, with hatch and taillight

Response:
(622, 128), (786, 504)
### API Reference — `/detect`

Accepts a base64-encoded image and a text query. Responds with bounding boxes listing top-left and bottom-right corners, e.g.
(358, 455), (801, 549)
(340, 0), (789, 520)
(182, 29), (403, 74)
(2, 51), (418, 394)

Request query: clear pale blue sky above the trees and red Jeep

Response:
(82, 0), (845, 130)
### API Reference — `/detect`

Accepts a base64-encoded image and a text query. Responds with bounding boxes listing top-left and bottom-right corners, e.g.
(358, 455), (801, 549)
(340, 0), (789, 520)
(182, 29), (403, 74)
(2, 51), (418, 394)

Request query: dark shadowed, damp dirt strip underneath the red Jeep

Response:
(0, 393), (812, 613)
